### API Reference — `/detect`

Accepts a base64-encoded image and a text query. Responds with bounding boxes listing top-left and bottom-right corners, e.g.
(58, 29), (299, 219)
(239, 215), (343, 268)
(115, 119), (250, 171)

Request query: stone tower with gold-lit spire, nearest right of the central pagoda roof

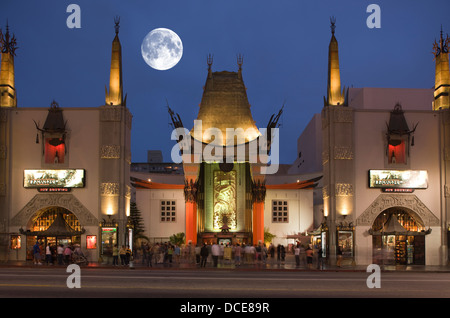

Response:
(322, 19), (355, 262)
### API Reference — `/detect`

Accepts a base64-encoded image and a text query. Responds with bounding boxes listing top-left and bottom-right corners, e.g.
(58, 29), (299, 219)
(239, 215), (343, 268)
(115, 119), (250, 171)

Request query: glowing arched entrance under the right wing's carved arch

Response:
(369, 208), (428, 265)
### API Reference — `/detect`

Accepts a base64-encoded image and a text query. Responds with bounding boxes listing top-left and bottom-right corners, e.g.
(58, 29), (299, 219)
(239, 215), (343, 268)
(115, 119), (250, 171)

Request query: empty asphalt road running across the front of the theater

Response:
(0, 267), (450, 299)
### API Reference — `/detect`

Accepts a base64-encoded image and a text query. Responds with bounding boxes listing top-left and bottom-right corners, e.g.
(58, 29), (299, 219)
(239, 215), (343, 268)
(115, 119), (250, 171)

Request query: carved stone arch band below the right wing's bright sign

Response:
(356, 194), (439, 226)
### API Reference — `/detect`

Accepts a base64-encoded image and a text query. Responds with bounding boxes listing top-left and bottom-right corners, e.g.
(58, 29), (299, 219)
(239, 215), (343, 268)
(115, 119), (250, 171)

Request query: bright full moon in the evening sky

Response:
(141, 28), (183, 71)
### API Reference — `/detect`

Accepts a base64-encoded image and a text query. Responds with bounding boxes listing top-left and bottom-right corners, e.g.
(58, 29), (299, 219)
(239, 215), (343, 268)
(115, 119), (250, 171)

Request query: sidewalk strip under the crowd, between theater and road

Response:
(0, 255), (450, 273)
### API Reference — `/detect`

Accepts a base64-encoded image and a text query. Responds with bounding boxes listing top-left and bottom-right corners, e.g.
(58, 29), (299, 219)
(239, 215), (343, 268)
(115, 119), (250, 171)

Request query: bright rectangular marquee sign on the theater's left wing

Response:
(23, 169), (85, 188)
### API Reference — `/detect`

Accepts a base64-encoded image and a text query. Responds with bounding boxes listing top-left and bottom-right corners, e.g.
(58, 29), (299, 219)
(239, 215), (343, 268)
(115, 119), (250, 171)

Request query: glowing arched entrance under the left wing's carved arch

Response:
(23, 207), (83, 260)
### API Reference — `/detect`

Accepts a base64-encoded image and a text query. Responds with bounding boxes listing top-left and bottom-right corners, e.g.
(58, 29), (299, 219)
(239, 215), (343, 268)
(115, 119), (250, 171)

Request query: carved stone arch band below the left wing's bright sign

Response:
(10, 193), (98, 226)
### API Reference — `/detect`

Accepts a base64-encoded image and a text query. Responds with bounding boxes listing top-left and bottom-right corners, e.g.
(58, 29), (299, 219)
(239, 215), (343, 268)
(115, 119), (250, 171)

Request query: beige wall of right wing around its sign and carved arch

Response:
(354, 110), (441, 265)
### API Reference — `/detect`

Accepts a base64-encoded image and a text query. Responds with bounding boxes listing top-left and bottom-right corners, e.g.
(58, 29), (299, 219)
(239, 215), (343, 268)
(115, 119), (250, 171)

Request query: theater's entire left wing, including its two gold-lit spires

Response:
(0, 20), (132, 261)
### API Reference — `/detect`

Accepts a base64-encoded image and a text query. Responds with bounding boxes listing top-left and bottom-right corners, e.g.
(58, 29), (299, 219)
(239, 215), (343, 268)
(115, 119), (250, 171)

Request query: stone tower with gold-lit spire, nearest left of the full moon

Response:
(99, 18), (132, 244)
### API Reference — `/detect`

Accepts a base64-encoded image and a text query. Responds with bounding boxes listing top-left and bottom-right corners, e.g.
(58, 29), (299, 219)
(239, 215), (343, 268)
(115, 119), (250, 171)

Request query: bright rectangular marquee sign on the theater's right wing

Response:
(369, 170), (428, 189)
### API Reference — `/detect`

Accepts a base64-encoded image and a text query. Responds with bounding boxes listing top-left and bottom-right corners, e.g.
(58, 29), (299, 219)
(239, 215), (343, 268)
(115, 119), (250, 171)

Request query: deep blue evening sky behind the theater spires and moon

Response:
(0, 0), (450, 163)
